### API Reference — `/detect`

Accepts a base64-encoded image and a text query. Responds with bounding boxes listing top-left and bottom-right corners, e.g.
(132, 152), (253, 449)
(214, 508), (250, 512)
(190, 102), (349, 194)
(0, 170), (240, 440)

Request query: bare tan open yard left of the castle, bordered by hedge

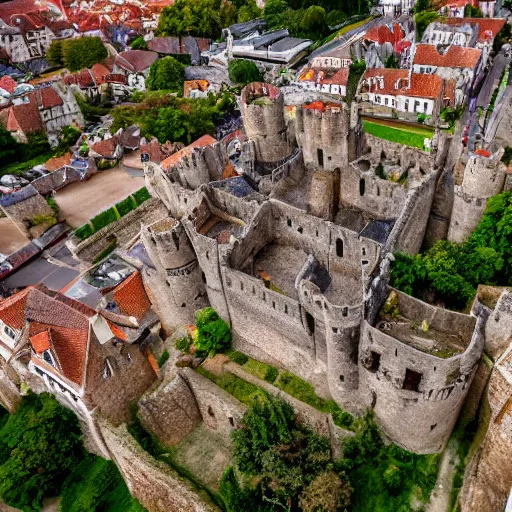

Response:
(55, 166), (144, 228)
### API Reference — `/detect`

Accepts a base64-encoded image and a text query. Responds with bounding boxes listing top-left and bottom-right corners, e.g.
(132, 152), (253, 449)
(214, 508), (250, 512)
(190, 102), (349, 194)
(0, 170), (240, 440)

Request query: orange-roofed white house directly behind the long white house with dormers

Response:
(413, 44), (483, 100)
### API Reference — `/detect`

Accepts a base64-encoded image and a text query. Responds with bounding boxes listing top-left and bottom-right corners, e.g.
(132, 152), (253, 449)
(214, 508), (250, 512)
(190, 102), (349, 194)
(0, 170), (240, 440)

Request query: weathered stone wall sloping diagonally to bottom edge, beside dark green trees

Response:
(100, 421), (218, 512)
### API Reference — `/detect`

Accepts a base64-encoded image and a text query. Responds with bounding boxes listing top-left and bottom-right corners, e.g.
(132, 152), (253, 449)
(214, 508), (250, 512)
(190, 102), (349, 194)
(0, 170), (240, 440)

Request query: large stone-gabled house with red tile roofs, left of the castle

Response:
(0, 271), (159, 452)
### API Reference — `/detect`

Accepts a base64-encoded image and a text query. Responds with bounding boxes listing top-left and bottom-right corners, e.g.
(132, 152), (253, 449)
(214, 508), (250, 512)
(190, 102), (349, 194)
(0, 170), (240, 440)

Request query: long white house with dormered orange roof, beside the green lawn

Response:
(359, 68), (453, 120)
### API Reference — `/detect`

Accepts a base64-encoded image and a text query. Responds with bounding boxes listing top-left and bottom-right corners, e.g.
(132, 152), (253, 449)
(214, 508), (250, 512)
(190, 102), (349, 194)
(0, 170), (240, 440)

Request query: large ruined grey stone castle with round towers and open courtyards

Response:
(135, 83), (504, 453)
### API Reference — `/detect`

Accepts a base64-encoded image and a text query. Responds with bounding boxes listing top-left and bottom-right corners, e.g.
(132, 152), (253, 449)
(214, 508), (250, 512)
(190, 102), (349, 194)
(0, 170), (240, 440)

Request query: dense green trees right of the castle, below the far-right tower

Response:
(391, 191), (512, 310)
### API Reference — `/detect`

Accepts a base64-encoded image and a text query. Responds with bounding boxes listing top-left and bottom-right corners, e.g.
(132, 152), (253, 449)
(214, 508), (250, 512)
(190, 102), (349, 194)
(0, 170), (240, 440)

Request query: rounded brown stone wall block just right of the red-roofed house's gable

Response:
(138, 373), (202, 446)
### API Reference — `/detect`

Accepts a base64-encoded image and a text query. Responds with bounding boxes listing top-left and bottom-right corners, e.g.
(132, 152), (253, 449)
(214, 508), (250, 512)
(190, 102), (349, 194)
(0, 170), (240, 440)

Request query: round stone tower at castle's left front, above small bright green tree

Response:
(141, 217), (208, 332)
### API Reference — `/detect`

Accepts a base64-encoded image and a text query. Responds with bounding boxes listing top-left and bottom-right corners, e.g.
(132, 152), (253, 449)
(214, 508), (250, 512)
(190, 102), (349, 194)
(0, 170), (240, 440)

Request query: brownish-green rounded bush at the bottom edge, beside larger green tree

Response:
(299, 471), (352, 512)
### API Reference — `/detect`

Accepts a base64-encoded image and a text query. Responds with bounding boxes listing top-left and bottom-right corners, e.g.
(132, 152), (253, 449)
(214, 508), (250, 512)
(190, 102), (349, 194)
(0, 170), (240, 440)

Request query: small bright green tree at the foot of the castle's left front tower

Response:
(194, 307), (231, 356)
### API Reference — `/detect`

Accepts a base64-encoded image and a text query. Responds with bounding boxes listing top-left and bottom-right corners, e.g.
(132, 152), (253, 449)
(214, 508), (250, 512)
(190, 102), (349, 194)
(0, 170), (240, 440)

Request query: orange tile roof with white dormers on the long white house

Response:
(363, 68), (443, 99)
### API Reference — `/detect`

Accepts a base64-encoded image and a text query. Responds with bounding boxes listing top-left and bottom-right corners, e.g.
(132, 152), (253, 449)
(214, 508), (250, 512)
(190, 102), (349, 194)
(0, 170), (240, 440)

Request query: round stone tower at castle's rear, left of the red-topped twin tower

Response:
(240, 82), (293, 166)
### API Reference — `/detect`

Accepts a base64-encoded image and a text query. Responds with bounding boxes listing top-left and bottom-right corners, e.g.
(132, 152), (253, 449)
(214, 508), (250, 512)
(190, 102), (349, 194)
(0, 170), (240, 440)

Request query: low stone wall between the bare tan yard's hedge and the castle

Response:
(66, 198), (167, 263)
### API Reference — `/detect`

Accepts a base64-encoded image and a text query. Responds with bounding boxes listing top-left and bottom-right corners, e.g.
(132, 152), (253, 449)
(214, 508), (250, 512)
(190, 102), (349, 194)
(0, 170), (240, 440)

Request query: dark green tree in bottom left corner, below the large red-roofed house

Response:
(0, 393), (84, 511)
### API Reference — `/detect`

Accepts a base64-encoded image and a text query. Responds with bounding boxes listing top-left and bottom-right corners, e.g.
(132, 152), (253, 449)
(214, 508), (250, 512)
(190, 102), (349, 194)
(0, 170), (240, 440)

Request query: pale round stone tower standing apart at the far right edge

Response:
(448, 149), (507, 242)
